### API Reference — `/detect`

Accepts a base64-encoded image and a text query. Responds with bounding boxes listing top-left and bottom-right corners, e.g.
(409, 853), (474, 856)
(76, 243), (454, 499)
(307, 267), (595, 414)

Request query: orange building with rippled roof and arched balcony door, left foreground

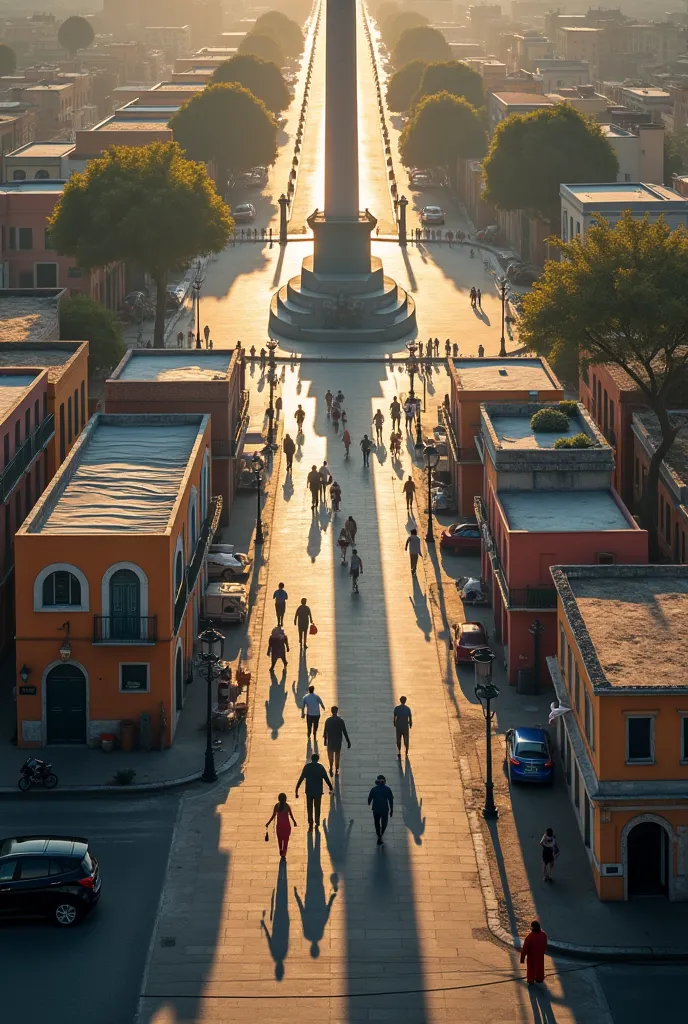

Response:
(15, 414), (221, 748)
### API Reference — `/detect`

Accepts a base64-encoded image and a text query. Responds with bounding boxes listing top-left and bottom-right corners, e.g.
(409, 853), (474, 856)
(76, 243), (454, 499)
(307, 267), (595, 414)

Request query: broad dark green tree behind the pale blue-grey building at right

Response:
(483, 103), (618, 225)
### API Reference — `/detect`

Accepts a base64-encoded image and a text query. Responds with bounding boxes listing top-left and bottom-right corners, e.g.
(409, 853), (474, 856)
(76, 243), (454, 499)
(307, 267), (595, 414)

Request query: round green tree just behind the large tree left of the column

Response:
(170, 83), (277, 190)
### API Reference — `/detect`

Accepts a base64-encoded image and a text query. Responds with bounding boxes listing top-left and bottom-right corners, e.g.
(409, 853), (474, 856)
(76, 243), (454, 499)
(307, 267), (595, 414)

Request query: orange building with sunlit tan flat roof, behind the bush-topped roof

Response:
(442, 358), (564, 516)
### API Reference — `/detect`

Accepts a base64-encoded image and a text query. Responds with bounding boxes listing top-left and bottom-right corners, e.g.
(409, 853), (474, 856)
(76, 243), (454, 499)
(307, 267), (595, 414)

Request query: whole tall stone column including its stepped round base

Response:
(270, 0), (416, 341)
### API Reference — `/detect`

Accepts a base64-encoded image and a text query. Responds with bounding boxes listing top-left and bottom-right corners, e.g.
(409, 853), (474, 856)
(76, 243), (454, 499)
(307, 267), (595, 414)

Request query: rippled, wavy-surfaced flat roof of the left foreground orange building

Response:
(28, 415), (207, 535)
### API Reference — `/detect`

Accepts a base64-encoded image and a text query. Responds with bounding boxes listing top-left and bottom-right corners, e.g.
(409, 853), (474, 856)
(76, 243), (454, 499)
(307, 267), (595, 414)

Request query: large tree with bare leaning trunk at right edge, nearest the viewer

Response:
(519, 210), (688, 559)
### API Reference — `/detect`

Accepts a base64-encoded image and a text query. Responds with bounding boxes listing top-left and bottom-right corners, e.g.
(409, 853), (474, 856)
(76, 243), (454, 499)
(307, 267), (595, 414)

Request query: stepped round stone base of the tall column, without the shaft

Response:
(269, 211), (416, 342)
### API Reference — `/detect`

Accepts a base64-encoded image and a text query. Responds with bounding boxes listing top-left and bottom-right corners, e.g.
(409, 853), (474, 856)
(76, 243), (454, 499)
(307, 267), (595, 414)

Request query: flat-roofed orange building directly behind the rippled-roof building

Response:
(104, 348), (249, 524)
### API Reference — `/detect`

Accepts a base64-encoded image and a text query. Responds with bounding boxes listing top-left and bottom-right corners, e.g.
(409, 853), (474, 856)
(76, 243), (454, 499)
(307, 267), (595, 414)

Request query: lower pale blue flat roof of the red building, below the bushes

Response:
(499, 490), (633, 534)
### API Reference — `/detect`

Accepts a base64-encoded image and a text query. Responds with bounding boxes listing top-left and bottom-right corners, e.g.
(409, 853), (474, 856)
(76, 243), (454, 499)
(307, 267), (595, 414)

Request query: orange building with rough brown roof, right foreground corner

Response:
(548, 565), (688, 900)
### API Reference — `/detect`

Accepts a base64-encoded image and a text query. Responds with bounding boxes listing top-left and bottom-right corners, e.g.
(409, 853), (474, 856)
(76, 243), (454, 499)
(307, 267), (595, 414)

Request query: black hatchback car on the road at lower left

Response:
(0, 836), (100, 928)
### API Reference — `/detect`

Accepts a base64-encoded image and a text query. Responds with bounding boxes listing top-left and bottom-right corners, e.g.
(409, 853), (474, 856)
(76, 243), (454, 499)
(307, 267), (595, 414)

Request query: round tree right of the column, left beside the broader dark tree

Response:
(399, 92), (485, 177)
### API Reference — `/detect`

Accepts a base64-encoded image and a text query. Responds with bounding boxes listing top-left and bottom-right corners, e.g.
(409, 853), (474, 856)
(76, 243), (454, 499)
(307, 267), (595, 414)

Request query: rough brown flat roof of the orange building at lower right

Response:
(552, 565), (688, 691)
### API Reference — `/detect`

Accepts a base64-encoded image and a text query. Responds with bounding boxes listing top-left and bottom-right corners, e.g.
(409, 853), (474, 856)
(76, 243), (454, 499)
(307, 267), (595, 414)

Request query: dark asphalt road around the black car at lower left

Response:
(0, 795), (179, 1024)
